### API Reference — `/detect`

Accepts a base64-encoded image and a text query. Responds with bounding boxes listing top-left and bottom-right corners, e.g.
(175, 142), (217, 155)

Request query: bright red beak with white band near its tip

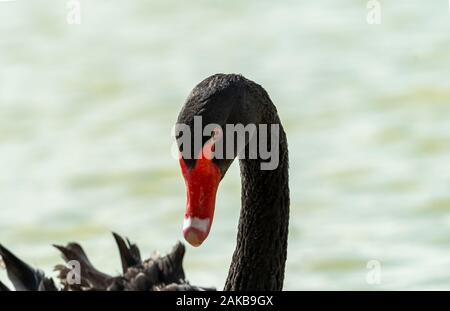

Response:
(180, 145), (221, 247)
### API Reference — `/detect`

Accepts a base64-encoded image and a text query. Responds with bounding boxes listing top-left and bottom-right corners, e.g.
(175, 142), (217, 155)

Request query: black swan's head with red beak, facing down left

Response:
(175, 74), (251, 246)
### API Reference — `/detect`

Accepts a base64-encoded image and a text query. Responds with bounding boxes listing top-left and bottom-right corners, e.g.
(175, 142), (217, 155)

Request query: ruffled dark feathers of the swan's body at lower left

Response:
(0, 233), (214, 291)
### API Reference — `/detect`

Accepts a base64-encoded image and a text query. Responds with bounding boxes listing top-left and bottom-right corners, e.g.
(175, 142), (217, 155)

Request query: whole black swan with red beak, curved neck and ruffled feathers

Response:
(0, 74), (289, 291)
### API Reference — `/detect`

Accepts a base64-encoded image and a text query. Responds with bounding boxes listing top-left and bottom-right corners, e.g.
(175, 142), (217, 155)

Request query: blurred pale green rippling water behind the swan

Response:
(0, 0), (450, 290)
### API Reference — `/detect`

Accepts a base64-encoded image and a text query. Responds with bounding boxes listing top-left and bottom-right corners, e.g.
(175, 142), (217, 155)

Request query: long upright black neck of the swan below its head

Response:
(225, 125), (289, 290)
